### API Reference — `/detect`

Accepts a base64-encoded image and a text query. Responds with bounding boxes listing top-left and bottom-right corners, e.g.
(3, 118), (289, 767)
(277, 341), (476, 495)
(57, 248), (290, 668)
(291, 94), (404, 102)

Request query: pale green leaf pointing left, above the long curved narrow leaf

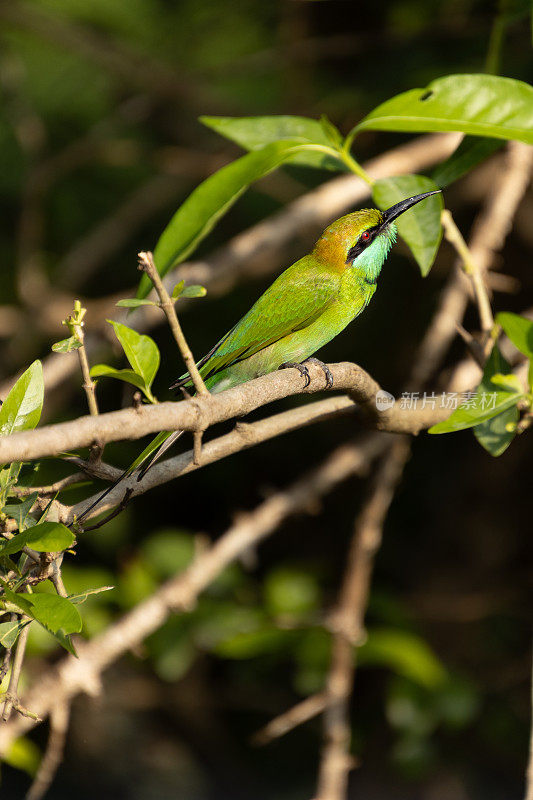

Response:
(200, 115), (345, 171)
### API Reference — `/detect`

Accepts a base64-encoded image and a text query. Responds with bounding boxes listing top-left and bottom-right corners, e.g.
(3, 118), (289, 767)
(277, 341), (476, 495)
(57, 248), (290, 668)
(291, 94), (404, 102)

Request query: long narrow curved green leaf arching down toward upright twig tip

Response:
(137, 139), (340, 297)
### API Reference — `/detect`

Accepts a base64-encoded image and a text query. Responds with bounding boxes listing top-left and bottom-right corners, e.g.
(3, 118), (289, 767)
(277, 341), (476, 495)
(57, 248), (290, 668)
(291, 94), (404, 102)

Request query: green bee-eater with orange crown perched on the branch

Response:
(80, 190), (438, 519)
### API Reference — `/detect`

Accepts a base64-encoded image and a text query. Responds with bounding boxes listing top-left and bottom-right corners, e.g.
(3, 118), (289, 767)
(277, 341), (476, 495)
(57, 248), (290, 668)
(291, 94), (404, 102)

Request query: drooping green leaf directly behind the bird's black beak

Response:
(372, 175), (443, 275)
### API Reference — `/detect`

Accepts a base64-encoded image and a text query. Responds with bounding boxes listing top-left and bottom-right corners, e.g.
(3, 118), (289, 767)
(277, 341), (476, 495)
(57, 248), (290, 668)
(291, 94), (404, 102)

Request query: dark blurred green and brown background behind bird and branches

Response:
(0, 0), (533, 800)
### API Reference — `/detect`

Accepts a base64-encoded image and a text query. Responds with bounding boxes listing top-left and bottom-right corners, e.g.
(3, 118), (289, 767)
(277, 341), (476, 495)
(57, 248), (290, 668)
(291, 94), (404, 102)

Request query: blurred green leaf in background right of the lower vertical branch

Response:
(357, 628), (447, 689)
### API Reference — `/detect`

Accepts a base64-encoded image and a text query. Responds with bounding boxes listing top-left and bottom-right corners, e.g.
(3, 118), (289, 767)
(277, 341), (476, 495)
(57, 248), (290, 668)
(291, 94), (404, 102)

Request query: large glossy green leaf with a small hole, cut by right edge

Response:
(355, 75), (533, 144)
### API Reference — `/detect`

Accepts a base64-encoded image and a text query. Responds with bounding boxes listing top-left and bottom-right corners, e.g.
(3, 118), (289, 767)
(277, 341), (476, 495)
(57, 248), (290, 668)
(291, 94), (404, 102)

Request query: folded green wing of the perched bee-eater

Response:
(175, 256), (340, 385)
